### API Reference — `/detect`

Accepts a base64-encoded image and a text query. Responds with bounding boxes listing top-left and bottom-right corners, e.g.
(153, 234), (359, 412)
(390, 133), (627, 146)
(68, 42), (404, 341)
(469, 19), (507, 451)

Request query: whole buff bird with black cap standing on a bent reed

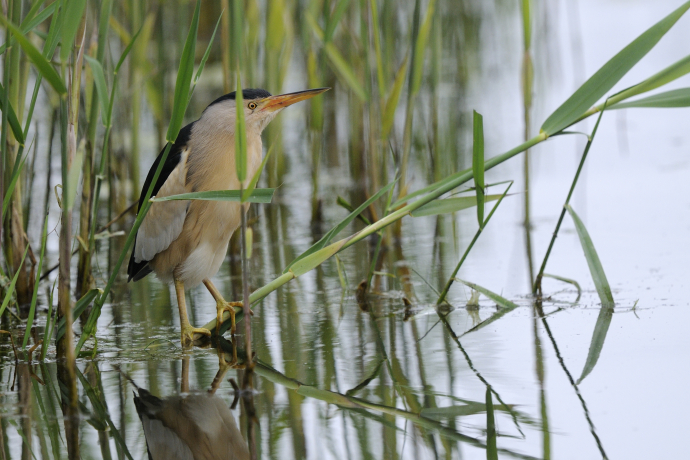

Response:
(127, 88), (330, 346)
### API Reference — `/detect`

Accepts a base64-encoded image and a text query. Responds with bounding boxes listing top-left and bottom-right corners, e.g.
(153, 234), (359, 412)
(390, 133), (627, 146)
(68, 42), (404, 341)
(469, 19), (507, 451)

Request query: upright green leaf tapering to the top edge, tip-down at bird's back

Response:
(165, 0), (201, 143)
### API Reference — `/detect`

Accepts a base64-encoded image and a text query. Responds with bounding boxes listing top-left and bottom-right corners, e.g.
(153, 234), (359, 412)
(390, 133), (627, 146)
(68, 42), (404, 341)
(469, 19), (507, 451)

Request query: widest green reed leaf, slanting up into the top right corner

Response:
(541, 1), (690, 136)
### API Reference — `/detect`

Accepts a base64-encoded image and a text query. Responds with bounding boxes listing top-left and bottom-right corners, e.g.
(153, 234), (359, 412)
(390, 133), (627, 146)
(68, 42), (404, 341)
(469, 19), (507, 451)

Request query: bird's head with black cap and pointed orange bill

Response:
(204, 88), (330, 133)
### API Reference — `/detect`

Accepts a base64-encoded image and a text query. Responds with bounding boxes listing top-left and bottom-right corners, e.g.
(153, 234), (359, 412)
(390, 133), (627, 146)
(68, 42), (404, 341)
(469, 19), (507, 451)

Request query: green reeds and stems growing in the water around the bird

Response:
(0, 0), (690, 458)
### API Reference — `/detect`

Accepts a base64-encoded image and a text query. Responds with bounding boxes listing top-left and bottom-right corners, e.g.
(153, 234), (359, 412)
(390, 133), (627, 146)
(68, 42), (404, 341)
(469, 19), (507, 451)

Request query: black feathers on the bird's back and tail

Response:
(127, 123), (194, 282)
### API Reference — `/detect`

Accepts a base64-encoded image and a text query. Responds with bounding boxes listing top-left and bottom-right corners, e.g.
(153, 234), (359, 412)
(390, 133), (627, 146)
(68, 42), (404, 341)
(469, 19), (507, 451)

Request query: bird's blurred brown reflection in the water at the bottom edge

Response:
(129, 338), (249, 460)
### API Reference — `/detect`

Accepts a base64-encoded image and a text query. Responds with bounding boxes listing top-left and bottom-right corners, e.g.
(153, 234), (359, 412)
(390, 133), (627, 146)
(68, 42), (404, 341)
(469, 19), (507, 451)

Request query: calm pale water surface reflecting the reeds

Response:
(0, 0), (690, 459)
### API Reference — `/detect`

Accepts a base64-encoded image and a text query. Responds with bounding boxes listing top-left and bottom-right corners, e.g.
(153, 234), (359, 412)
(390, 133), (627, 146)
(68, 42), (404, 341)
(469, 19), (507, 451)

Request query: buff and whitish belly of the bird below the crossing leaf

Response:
(175, 201), (241, 288)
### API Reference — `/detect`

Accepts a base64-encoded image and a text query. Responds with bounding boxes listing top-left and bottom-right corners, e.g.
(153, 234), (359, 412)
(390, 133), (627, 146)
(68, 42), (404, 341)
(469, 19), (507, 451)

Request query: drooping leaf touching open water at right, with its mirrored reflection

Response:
(567, 205), (615, 384)
